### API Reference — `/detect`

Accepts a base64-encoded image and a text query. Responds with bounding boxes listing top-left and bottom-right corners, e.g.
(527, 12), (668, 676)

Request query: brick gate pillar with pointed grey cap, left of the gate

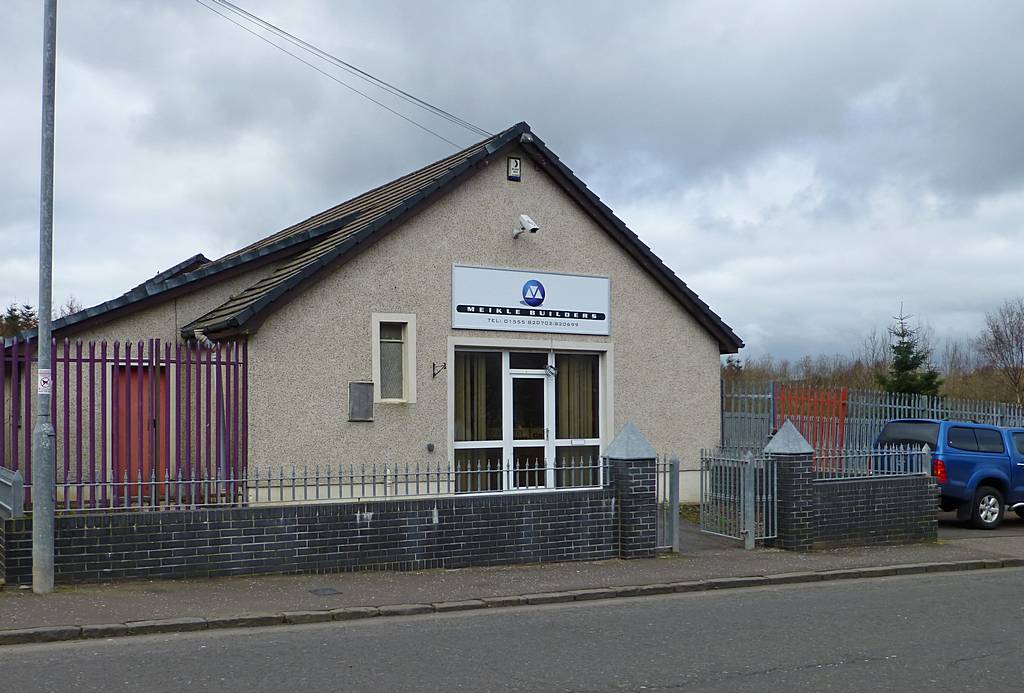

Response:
(605, 423), (655, 558)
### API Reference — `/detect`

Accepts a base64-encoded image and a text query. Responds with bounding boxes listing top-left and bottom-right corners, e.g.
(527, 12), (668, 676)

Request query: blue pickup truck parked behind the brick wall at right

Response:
(877, 419), (1024, 529)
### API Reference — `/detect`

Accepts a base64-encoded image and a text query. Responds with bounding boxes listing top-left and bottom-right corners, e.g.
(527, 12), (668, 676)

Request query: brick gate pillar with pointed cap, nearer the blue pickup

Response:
(764, 419), (817, 550)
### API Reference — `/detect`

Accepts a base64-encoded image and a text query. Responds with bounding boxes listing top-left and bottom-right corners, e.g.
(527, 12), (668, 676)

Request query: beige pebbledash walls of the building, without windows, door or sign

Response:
(66, 148), (720, 502)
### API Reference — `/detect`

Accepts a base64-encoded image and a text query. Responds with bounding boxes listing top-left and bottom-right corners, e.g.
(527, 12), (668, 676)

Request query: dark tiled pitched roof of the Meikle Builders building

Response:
(9, 123), (743, 352)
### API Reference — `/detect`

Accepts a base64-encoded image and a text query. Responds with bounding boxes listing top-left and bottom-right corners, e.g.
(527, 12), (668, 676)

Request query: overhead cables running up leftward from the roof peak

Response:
(196, 0), (490, 148)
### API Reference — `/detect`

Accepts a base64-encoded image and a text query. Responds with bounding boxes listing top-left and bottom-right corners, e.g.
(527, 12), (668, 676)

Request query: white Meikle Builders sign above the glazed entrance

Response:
(452, 265), (608, 335)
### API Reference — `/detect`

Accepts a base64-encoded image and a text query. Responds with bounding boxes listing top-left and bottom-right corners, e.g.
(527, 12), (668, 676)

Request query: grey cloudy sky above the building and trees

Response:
(0, 0), (1024, 356)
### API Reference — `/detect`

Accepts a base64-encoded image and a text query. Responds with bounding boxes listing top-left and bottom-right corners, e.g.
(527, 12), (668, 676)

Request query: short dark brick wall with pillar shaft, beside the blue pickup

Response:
(773, 448), (939, 551)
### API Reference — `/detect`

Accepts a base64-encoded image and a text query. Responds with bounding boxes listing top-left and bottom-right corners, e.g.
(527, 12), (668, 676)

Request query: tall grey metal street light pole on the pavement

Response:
(32, 0), (57, 595)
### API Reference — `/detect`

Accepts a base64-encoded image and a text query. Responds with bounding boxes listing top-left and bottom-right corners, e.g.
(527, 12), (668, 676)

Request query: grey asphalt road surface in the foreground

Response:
(6, 569), (1024, 693)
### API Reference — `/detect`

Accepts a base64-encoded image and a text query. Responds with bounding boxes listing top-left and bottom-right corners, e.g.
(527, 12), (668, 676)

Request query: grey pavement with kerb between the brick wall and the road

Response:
(0, 514), (1024, 644)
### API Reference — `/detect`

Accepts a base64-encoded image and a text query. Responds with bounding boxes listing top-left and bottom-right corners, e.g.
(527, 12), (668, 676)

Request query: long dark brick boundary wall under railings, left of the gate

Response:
(0, 488), (614, 584)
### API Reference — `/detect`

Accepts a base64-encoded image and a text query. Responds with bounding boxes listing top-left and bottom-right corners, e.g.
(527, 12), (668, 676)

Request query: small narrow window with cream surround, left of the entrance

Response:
(370, 313), (416, 403)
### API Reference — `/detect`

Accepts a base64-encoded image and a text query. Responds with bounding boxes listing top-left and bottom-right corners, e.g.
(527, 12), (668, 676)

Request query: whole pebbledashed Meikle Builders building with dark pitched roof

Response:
(0, 123), (742, 500)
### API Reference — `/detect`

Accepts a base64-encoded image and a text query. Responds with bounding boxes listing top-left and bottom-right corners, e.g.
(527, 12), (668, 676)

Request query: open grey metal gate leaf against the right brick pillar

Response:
(700, 449), (778, 549)
